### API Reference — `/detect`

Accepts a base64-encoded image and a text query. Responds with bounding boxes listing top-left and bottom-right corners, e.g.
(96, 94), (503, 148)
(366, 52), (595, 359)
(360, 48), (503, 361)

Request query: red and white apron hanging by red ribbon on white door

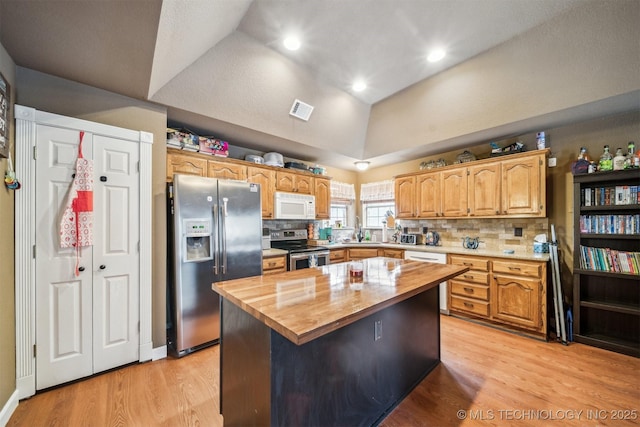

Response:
(60, 132), (93, 276)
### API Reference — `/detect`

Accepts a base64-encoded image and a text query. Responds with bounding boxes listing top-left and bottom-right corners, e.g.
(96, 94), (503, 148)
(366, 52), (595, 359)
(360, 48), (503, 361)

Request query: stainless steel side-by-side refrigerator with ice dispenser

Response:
(167, 174), (262, 356)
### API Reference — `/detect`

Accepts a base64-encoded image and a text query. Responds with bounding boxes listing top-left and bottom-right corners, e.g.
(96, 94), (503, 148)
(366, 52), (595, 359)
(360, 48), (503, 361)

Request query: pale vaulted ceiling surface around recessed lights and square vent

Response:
(0, 0), (592, 168)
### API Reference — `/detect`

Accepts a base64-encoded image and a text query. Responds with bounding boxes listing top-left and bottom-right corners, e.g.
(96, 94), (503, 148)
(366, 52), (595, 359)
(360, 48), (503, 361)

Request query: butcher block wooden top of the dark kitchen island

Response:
(212, 257), (468, 345)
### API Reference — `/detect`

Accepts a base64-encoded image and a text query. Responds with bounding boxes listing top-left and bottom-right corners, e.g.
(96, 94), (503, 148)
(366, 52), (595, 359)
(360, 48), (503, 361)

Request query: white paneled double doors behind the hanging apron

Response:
(35, 125), (140, 389)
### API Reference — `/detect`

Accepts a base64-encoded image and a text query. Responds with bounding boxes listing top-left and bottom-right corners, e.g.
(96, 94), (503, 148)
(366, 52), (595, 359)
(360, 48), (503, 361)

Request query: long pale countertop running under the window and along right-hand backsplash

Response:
(325, 242), (549, 262)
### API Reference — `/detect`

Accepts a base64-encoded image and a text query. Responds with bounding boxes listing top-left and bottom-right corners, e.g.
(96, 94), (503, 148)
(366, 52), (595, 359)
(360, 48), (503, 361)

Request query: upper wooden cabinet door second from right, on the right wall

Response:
(468, 163), (501, 216)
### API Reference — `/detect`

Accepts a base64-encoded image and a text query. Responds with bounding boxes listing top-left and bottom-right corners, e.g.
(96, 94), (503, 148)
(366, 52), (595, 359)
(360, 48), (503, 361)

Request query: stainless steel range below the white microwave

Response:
(271, 229), (329, 271)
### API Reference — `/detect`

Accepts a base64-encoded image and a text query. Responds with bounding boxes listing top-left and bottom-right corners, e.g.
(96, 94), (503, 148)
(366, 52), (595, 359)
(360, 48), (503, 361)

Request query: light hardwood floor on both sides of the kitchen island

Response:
(8, 316), (640, 427)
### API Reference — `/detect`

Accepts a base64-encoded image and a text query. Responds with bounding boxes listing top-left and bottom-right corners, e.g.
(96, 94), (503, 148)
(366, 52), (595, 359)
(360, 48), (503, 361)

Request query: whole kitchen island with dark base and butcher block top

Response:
(212, 257), (467, 426)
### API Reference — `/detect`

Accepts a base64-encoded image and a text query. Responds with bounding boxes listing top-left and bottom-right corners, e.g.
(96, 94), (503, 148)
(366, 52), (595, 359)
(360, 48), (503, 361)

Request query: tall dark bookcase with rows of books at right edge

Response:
(573, 169), (640, 357)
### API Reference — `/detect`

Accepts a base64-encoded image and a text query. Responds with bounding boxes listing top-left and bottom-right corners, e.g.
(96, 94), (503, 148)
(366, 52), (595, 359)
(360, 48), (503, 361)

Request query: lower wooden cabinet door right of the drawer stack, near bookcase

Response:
(490, 274), (542, 330)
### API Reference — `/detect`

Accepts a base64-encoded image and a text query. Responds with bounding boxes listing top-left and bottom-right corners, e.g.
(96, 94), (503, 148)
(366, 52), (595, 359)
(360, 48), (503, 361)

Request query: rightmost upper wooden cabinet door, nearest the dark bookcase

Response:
(501, 155), (546, 216)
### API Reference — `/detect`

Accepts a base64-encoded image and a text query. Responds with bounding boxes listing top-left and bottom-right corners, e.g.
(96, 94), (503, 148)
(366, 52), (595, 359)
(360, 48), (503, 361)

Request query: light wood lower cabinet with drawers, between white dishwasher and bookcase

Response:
(448, 254), (547, 338)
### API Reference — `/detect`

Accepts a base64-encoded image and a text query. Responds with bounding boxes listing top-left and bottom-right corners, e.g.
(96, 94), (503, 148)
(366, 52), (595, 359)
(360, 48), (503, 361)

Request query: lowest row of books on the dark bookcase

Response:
(580, 245), (640, 275)
